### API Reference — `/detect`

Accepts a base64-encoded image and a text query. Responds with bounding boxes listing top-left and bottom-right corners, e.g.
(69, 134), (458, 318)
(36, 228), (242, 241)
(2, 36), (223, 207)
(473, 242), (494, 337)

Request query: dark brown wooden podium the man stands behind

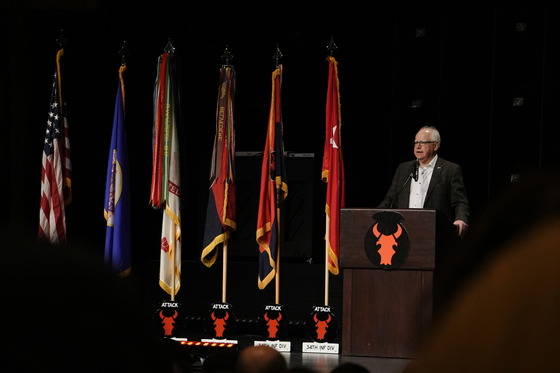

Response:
(339, 208), (450, 358)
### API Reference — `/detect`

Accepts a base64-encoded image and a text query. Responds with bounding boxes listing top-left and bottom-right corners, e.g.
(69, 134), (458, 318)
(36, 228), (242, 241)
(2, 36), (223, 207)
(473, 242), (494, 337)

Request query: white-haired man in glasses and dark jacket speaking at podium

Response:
(377, 126), (470, 237)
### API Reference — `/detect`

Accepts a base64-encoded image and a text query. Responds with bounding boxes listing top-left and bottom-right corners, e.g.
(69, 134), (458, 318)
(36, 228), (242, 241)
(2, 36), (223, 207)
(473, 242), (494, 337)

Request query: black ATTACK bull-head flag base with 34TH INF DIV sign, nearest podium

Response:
(301, 306), (339, 354)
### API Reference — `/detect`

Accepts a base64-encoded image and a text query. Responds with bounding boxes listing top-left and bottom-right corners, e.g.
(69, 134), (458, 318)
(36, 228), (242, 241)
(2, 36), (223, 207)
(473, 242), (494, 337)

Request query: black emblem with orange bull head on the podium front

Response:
(365, 211), (410, 269)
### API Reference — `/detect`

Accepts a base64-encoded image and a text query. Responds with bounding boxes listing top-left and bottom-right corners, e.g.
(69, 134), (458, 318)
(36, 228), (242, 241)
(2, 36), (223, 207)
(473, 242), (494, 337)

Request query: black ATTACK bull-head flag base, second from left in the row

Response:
(201, 302), (237, 344)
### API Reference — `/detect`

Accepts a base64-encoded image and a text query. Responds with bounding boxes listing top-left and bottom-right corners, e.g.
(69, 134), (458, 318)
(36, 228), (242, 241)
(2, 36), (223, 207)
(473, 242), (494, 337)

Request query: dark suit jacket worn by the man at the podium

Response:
(377, 156), (470, 223)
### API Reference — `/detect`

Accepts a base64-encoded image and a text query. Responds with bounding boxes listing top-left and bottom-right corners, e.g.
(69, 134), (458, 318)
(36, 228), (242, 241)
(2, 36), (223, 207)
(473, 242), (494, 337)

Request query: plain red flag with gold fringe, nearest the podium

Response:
(321, 57), (345, 275)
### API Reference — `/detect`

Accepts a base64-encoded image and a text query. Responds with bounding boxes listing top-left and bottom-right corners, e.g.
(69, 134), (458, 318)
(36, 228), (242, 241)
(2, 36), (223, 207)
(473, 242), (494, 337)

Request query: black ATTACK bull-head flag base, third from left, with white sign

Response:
(254, 304), (292, 352)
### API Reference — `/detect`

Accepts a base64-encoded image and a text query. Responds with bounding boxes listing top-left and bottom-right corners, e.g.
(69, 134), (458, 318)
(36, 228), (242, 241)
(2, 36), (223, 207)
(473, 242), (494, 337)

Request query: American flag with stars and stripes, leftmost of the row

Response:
(38, 49), (72, 245)
